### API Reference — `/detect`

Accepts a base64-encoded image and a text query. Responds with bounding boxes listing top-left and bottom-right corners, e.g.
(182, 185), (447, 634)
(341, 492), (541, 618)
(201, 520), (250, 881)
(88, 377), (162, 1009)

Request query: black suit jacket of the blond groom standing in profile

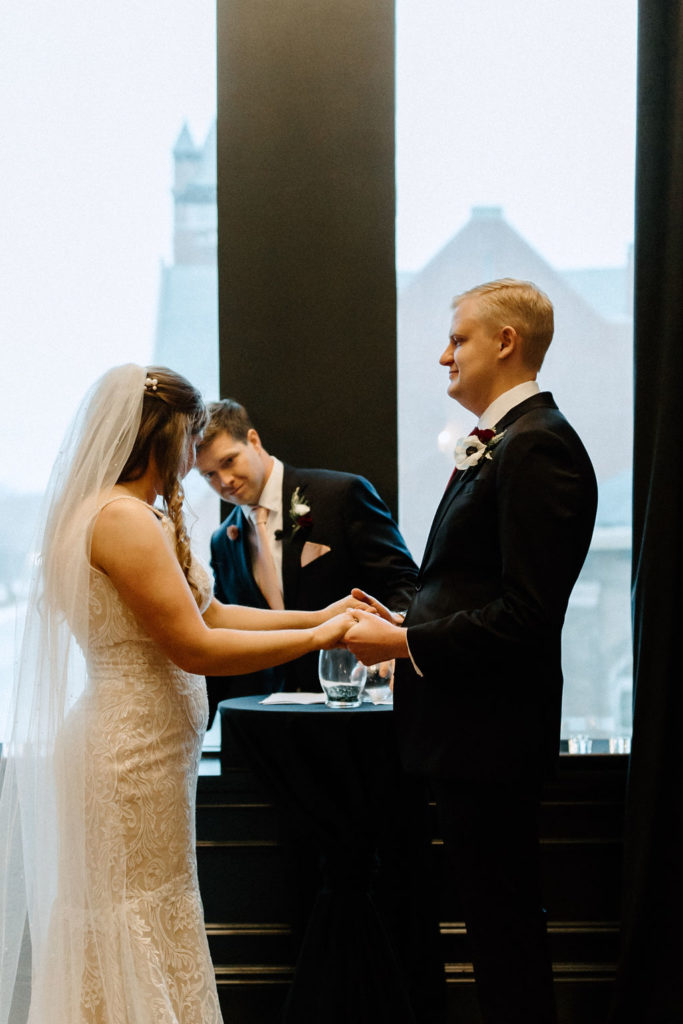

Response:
(394, 392), (597, 791)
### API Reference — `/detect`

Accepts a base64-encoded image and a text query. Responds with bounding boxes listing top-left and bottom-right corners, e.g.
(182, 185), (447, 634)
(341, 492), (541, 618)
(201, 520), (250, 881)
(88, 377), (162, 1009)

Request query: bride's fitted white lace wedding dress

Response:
(30, 498), (222, 1024)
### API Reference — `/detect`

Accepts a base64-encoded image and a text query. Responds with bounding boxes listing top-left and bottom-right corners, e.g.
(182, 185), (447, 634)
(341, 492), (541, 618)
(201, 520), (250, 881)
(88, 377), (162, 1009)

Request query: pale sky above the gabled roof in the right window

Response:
(396, 0), (637, 268)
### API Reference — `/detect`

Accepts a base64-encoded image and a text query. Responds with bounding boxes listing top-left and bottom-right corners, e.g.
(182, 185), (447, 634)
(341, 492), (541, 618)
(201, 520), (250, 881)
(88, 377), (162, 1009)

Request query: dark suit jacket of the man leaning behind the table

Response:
(208, 465), (418, 717)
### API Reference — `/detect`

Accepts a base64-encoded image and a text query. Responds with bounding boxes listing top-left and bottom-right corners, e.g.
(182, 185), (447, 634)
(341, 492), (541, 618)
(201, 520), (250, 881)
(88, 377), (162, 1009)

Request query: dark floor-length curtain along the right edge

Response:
(612, 0), (683, 1024)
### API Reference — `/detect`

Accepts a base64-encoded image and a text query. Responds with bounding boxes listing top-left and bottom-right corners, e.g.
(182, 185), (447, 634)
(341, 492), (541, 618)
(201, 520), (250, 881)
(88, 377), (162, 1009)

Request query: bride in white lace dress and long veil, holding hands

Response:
(0, 365), (359, 1024)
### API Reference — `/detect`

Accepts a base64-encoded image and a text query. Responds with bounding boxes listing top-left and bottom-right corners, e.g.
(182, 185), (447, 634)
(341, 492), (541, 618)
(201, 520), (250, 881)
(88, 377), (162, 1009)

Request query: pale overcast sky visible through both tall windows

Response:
(0, 0), (636, 489)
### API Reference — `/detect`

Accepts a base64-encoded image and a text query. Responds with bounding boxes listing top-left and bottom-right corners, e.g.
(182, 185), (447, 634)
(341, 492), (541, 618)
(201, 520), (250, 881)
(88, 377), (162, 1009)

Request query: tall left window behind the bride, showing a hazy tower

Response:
(0, 0), (218, 741)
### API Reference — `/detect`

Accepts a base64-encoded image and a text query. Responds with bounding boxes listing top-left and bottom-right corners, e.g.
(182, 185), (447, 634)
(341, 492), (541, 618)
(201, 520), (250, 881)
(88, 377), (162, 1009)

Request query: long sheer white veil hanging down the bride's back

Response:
(0, 364), (145, 1024)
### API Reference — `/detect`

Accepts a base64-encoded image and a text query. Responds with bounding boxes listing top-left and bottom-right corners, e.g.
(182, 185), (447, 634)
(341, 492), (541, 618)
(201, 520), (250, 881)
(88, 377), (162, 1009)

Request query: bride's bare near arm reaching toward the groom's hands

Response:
(90, 502), (352, 676)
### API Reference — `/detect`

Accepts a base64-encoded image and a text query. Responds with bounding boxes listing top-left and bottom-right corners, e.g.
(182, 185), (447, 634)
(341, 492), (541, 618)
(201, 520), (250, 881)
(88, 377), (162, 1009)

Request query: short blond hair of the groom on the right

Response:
(452, 278), (555, 370)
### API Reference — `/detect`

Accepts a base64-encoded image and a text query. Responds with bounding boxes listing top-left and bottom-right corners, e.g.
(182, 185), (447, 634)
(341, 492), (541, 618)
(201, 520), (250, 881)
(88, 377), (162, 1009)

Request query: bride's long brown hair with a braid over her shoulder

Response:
(117, 367), (207, 590)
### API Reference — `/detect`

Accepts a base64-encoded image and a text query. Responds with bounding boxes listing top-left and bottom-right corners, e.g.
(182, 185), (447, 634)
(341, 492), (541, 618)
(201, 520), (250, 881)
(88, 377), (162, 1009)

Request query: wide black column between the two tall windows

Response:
(218, 0), (397, 512)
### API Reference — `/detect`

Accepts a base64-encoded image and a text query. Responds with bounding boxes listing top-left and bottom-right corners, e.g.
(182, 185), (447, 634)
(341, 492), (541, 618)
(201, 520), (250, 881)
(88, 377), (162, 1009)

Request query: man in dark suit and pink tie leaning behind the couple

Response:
(197, 398), (418, 722)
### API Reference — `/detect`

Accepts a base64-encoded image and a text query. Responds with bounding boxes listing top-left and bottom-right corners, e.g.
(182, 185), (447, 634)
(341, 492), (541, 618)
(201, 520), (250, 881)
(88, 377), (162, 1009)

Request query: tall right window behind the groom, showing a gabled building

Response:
(396, 0), (637, 750)
